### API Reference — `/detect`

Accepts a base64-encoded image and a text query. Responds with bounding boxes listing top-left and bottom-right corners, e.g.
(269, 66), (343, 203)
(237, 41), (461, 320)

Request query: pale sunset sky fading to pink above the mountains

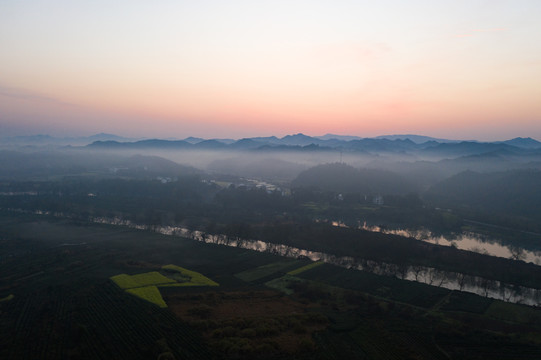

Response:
(0, 0), (541, 140)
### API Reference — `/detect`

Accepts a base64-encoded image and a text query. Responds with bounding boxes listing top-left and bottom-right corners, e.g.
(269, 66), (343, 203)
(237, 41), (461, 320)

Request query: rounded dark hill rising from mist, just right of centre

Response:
(292, 163), (418, 195)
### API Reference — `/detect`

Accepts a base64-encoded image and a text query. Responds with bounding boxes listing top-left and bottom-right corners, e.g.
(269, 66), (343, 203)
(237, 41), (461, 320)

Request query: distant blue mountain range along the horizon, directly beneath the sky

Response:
(4, 133), (541, 157)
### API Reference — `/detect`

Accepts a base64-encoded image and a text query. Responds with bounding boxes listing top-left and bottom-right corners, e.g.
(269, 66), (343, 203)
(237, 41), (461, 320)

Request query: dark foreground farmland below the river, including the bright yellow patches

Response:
(0, 215), (541, 360)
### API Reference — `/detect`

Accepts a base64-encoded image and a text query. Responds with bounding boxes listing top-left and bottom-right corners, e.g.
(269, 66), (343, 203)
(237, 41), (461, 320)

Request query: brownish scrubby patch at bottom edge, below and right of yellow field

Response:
(167, 290), (328, 359)
